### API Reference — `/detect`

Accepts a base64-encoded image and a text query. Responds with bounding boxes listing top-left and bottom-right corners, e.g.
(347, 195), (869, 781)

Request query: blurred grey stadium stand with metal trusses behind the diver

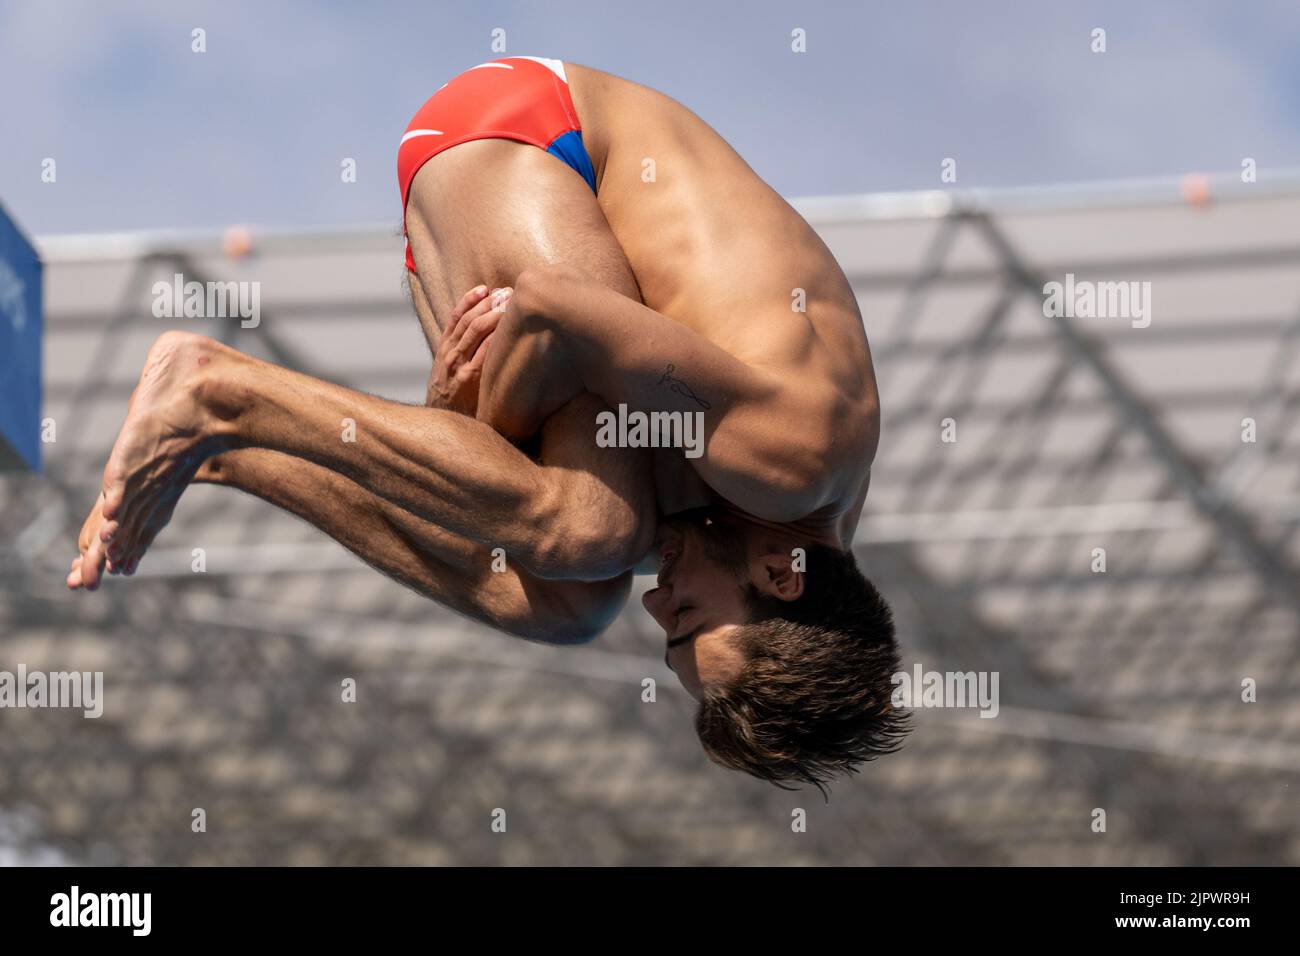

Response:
(0, 177), (1300, 864)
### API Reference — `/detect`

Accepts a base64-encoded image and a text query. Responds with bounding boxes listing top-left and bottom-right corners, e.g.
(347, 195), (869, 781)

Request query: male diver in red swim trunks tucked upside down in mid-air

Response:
(68, 57), (906, 786)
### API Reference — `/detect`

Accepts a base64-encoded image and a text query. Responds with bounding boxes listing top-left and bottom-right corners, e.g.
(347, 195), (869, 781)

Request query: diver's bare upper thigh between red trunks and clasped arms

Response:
(406, 139), (641, 347)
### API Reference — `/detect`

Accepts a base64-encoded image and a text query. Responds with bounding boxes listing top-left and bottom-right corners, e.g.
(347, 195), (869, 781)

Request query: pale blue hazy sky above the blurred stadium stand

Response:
(0, 0), (1300, 233)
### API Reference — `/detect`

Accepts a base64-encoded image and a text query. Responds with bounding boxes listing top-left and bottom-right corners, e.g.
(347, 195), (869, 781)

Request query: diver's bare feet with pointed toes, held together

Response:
(75, 332), (222, 591)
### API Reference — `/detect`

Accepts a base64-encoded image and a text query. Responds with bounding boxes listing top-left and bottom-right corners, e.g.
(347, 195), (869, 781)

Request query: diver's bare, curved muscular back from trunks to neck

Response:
(566, 64), (879, 540)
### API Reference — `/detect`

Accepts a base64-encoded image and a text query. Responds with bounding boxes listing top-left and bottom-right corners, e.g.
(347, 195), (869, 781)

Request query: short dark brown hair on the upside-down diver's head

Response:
(696, 545), (909, 796)
